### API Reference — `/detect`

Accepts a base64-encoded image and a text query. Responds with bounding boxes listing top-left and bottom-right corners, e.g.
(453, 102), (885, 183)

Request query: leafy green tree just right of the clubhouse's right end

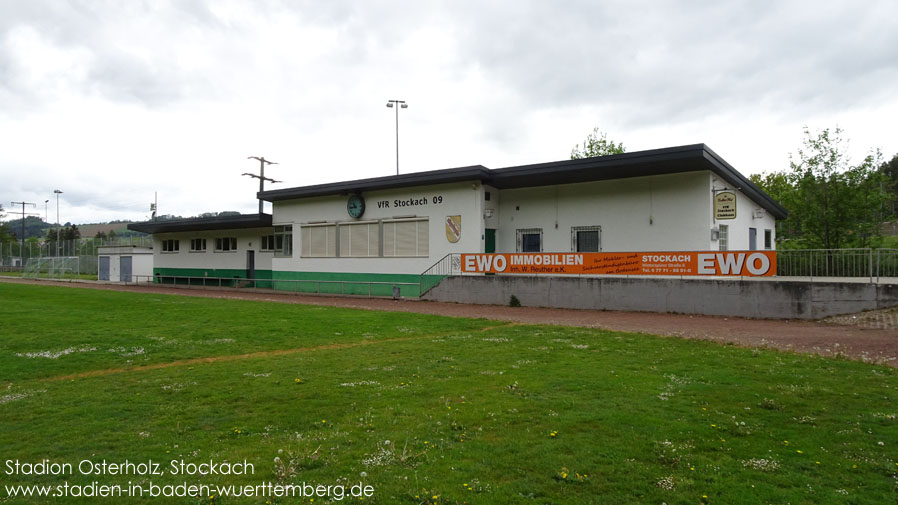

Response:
(752, 127), (887, 249)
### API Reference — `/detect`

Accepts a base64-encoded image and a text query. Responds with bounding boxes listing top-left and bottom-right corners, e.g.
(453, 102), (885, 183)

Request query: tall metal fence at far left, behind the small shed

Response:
(0, 237), (153, 274)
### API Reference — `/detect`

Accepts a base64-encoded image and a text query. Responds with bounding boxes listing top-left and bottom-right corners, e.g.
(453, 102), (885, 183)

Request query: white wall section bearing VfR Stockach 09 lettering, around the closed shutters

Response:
(272, 181), (483, 274)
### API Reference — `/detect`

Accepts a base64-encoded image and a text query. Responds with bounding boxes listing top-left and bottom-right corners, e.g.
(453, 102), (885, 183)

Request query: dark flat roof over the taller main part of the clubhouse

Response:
(258, 144), (788, 219)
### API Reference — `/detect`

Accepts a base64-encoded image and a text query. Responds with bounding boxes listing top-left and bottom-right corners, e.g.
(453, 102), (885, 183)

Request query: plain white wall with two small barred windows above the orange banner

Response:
(496, 171), (711, 252)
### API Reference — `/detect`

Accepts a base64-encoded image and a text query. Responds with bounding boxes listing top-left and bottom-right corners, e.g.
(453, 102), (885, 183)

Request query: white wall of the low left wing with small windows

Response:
(153, 228), (274, 271)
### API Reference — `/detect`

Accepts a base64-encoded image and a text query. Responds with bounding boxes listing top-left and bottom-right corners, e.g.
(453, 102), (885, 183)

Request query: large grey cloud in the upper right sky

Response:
(440, 2), (898, 126)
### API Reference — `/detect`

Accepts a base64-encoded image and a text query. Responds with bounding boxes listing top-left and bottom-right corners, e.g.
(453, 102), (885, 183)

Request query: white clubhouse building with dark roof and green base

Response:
(128, 144), (786, 295)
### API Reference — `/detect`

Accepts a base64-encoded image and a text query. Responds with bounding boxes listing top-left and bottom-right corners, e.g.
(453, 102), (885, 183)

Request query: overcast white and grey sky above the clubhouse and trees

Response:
(0, 0), (898, 223)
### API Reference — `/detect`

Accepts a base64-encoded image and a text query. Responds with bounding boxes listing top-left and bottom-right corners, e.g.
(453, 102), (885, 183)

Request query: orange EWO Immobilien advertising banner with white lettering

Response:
(461, 251), (776, 277)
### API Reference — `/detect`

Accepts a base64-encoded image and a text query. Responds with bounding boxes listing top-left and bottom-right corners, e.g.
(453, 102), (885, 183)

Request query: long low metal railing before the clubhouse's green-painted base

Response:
(123, 275), (420, 298)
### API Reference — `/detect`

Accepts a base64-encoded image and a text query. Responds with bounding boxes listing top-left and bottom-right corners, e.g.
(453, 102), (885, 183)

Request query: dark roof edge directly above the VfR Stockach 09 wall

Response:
(257, 165), (490, 202)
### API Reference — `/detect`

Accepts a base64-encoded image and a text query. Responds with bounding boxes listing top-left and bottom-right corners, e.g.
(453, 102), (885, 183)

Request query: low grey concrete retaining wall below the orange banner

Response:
(423, 276), (898, 319)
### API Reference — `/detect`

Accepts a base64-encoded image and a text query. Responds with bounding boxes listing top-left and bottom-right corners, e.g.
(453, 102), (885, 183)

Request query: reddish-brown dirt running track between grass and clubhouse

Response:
(0, 277), (898, 367)
